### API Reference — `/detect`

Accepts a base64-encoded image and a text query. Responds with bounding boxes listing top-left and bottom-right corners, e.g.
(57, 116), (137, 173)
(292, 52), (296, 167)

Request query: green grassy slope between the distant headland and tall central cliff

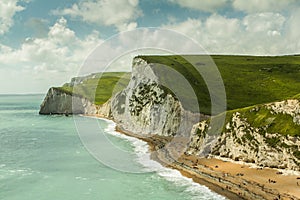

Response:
(58, 72), (130, 105)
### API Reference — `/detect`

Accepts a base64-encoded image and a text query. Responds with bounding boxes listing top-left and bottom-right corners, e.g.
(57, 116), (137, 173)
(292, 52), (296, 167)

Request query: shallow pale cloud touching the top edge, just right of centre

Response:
(169, 0), (228, 12)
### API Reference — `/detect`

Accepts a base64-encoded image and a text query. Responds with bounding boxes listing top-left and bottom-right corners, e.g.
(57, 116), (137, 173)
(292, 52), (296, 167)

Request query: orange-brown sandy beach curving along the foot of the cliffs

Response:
(87, 115), (300, 200)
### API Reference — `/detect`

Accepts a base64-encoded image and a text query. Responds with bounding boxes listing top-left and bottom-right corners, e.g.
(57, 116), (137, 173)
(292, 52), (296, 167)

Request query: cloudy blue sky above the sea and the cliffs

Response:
(0, 0), (300, 94)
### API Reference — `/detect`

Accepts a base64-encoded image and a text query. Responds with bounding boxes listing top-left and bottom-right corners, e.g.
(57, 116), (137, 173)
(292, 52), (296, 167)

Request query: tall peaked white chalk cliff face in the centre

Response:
(111, 58), (182, 136)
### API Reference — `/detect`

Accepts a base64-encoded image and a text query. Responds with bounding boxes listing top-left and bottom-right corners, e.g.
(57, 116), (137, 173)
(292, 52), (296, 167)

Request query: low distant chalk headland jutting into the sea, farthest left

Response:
(39, 87), (98, 115)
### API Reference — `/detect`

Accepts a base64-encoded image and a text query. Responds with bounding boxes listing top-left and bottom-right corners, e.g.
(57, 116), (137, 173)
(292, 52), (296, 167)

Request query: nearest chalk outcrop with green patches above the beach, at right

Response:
(187, 100), (300, 171)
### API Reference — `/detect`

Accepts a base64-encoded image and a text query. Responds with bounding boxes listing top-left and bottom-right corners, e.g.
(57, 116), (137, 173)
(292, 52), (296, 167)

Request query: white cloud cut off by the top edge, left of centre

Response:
(53, 0), (142, 30)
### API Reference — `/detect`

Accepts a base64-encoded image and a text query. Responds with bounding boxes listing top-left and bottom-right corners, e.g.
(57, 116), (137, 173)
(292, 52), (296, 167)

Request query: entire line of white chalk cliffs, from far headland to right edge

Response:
(40, 57), (300, 170)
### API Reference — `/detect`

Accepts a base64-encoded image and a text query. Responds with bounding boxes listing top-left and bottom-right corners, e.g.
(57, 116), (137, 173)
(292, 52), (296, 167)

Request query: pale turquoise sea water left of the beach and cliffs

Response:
(0, 95), (223, 200)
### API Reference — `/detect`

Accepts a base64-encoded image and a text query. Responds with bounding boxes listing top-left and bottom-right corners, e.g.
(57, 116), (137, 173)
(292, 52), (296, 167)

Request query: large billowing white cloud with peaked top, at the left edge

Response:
(0, 18), (101, 70)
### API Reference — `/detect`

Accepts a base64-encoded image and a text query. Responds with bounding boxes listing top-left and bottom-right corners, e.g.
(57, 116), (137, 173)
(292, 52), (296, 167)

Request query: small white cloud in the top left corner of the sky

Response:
(0, 0), (25, 35)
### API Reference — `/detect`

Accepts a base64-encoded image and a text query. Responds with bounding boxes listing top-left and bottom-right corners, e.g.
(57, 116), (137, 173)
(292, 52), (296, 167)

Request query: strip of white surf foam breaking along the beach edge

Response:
(97, 119), (226, 200)
